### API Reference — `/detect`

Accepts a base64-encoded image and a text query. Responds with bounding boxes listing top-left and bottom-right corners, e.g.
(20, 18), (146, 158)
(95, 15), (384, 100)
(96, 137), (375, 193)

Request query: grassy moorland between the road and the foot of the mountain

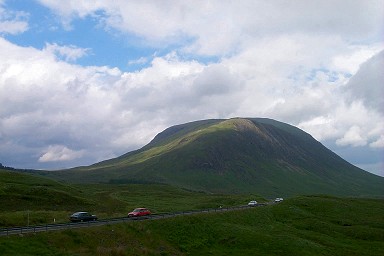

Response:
(0, 170), (264, 227)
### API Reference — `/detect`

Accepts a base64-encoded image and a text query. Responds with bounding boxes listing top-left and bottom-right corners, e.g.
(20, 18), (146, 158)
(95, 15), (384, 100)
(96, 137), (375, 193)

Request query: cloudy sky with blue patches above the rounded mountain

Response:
(0, 0), (384, 176)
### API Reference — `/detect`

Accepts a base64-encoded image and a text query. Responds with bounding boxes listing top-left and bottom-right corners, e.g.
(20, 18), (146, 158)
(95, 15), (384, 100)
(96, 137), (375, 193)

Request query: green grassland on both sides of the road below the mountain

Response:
(0, 170), (384, 256)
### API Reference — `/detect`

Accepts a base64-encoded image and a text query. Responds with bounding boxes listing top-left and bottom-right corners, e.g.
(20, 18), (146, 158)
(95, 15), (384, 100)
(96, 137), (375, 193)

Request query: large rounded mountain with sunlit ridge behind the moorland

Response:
(37, 118), (384, 196)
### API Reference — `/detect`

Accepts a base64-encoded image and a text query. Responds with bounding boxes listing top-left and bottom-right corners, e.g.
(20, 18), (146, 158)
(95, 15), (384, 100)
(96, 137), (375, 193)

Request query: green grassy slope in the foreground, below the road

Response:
(0, 196), (384, 255)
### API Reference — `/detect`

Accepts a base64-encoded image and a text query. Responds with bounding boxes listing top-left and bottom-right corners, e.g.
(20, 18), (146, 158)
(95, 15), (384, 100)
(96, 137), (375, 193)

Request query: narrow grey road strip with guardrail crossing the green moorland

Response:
(0, 204), (266, 236)
